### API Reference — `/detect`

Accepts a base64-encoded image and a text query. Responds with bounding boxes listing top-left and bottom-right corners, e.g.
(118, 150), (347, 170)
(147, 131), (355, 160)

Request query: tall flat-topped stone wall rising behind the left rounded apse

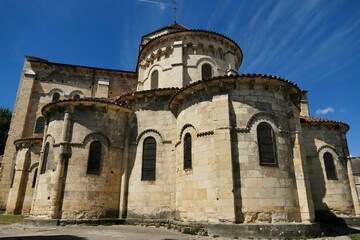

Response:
(0, 57), (137, 212)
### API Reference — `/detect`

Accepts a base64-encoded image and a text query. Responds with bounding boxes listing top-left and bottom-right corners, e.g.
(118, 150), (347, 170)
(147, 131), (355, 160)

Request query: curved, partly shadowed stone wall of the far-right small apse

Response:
(302, 123), (354, 216)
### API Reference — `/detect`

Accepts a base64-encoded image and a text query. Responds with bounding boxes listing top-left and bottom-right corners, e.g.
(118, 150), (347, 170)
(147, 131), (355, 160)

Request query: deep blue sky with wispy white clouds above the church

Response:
(0, 0), (360, 156)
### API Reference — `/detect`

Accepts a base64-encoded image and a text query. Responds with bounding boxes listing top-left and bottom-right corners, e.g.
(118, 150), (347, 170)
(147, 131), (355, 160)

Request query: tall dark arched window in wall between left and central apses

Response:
(141, 137), (156, 180)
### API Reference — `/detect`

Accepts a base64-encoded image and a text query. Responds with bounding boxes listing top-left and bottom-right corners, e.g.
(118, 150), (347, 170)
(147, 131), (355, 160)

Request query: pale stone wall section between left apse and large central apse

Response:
(127, 98), (177, 219)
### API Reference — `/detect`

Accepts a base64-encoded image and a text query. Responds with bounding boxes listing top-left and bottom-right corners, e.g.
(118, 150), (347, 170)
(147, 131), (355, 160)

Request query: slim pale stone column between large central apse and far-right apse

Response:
(293, 130), (315, 222)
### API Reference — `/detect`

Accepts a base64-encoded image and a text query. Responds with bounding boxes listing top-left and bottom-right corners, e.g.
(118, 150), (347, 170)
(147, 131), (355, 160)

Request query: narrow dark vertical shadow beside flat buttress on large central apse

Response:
(229, 100), (244, 223)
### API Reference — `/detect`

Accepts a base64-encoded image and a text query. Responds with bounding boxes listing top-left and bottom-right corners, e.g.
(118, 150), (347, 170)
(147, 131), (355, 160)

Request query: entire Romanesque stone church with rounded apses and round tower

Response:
(0, 23), (360, 224)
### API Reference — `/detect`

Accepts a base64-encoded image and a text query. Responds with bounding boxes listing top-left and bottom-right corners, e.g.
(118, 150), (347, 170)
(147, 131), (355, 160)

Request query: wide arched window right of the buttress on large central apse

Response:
(257, 122), (277, 165)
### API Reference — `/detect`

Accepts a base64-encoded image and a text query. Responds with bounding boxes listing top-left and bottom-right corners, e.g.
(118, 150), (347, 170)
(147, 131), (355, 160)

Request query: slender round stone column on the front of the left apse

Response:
(50, 109), (72, 219)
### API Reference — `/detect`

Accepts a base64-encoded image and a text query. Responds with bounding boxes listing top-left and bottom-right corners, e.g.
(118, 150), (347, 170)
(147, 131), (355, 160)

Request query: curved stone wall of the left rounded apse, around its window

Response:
(32, 101), (130, 219)
